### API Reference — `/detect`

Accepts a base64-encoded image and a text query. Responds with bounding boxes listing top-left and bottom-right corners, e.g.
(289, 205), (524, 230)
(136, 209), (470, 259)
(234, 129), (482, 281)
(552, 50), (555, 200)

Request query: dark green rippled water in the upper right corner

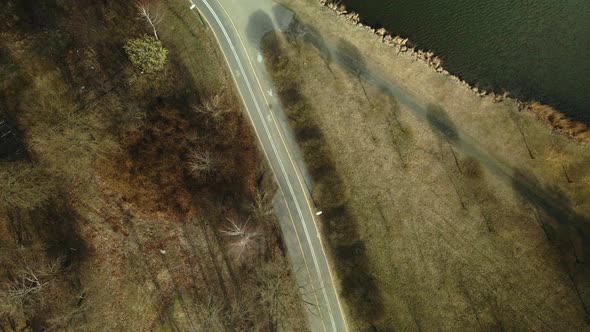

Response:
(343, 0), (590, 124)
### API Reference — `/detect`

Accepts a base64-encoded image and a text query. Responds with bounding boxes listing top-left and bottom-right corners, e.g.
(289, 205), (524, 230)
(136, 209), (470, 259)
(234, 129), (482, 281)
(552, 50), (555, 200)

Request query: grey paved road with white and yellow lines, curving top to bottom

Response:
(188, 0), (348, 331)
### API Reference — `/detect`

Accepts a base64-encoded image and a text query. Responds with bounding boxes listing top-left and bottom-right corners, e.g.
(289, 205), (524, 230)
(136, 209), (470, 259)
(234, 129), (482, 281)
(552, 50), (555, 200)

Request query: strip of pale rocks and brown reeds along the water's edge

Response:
(319, 0), (590, 143)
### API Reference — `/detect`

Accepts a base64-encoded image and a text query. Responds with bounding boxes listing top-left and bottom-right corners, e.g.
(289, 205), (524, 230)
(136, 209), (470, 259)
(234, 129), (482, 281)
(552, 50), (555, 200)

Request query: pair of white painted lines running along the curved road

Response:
(202, 0), (336, 331)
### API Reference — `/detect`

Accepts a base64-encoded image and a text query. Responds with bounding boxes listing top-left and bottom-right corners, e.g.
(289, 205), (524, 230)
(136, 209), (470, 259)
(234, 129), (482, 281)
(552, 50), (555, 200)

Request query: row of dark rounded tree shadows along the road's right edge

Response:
(263, 31), (384, 324)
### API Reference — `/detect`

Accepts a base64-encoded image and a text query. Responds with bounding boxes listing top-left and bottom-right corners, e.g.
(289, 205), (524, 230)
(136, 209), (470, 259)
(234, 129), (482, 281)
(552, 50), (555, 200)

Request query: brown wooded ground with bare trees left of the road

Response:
(0, 0), (305, 331)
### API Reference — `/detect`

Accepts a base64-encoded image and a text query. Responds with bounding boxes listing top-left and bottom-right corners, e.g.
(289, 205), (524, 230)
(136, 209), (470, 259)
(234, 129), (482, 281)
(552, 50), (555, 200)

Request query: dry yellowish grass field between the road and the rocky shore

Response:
(264, 16), (590, 331)
